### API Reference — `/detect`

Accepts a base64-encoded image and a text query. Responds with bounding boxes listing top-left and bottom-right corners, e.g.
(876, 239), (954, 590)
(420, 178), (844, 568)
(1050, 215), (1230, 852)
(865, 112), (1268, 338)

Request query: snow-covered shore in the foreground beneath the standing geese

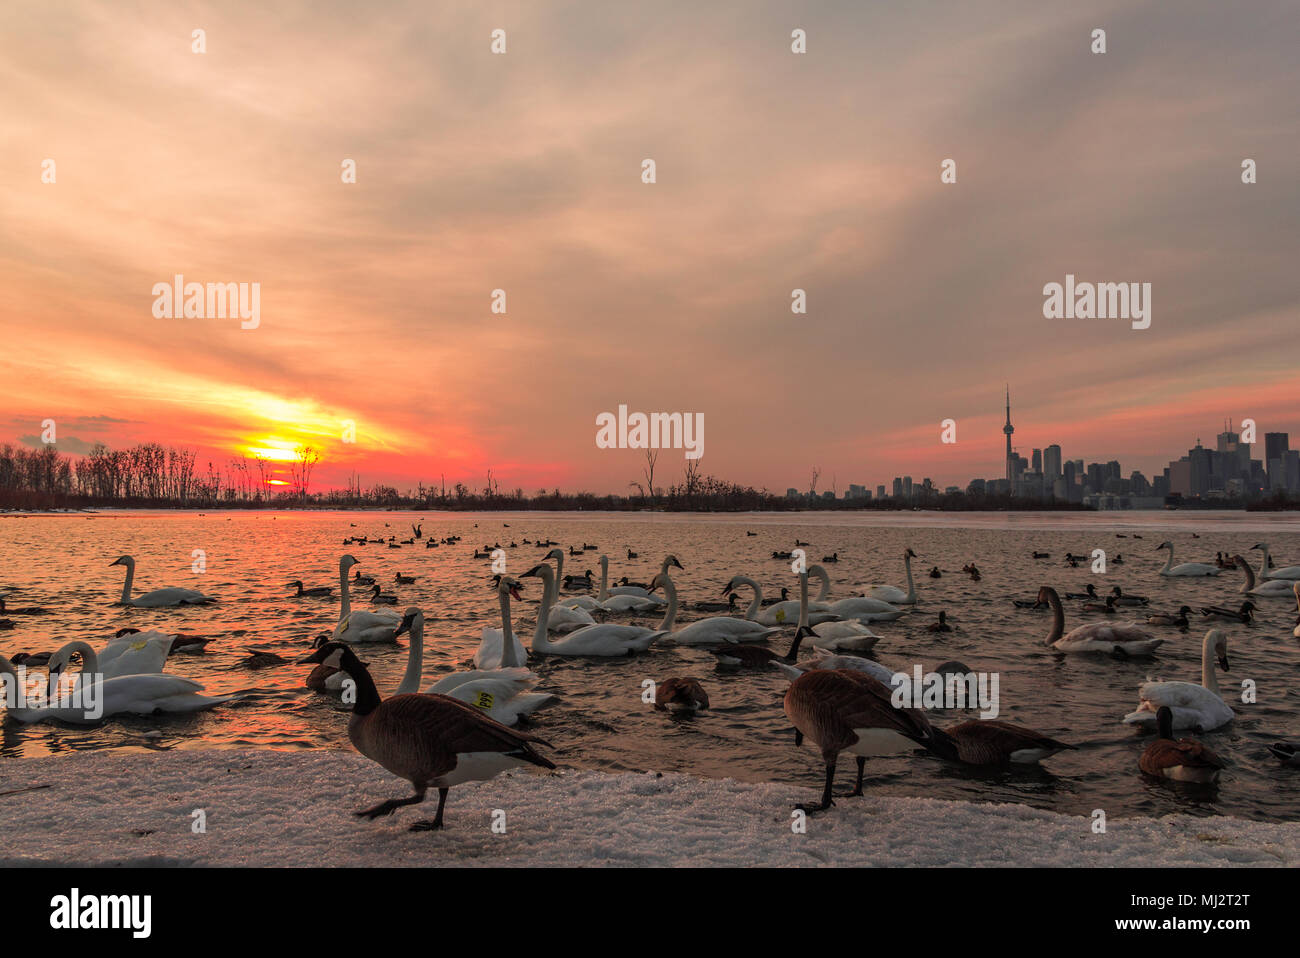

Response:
(0, 750), (1300, 867)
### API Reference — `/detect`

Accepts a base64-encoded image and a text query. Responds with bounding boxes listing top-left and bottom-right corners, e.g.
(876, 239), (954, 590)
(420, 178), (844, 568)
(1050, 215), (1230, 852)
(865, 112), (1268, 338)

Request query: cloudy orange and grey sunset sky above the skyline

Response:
(0, 0), (1300, 493)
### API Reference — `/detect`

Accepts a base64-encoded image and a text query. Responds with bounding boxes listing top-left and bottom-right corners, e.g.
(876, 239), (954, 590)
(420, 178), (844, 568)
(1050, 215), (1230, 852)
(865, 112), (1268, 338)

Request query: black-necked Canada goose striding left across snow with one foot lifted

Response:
(302, 641), (555, 832)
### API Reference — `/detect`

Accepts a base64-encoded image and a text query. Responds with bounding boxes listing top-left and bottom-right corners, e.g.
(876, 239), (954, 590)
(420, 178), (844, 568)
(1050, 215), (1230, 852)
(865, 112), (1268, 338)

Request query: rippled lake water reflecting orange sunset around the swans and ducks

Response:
(0, 512), (1300, 820)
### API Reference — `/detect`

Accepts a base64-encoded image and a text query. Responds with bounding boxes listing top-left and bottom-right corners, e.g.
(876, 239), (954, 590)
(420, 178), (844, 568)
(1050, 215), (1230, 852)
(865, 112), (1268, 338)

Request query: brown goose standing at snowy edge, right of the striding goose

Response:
(784, 668), (935, 812)
